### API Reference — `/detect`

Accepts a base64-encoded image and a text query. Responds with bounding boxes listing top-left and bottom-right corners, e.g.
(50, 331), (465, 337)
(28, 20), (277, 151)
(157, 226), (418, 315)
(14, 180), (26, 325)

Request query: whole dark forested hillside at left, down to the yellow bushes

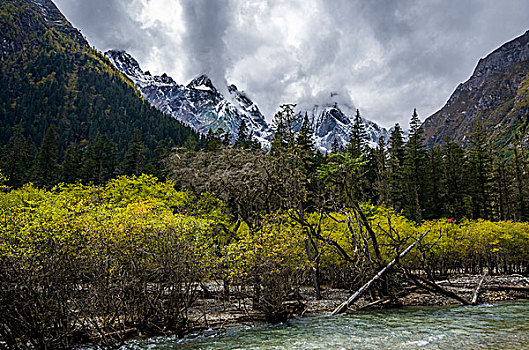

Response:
(0, 0), (198, 185)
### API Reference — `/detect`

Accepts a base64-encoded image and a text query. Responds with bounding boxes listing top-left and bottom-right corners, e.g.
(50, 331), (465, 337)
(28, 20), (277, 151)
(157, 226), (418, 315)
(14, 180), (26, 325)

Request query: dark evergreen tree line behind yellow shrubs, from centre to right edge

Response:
(195, 105), (529, 222)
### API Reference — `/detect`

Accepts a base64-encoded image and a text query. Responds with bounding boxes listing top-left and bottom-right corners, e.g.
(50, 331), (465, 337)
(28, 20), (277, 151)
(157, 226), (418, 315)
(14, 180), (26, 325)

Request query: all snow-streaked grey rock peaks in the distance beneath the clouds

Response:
(105, 50), (389, 152)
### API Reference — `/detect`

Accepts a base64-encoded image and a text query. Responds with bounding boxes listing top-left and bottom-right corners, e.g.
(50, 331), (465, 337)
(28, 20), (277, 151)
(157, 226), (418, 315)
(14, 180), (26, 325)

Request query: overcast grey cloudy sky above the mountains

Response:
(53, 0), (529, 127)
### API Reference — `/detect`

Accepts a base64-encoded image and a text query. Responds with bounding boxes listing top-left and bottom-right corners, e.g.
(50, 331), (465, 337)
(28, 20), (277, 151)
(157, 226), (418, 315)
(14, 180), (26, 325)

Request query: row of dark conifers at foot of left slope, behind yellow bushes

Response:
(0, 124), (188, 187)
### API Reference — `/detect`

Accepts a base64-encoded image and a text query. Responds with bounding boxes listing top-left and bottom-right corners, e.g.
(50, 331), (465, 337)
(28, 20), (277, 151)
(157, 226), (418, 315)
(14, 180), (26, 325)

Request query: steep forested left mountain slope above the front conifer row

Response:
(0, 0), (197, 160)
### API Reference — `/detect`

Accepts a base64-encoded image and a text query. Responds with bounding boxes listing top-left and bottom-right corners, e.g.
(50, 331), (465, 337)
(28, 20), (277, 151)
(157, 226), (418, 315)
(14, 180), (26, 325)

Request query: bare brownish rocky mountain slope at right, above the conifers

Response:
(423, 31), (529, 149)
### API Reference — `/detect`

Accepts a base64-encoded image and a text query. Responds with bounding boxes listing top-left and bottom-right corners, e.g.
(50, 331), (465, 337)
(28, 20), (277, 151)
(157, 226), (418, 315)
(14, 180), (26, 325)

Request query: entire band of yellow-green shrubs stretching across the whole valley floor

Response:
(0, 175), (529, 348)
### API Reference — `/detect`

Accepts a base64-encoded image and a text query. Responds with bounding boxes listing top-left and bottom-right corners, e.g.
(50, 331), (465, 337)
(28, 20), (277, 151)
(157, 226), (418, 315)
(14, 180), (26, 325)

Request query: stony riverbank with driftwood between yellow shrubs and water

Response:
(185, 275), (529, 332)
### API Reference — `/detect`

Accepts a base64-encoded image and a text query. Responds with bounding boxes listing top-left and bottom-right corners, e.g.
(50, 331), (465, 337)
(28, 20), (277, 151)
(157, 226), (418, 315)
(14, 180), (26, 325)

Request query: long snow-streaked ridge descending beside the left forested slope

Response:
(105, 50), (271, 144)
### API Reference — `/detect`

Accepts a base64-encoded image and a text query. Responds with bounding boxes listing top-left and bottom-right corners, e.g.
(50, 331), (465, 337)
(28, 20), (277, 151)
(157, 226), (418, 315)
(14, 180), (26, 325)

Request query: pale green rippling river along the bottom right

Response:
(123, 301), (529, 350)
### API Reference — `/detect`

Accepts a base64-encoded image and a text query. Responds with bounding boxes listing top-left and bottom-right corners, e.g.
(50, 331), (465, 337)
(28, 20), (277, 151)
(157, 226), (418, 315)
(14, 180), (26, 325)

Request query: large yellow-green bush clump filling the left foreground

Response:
(0, 176), (215, 348)
